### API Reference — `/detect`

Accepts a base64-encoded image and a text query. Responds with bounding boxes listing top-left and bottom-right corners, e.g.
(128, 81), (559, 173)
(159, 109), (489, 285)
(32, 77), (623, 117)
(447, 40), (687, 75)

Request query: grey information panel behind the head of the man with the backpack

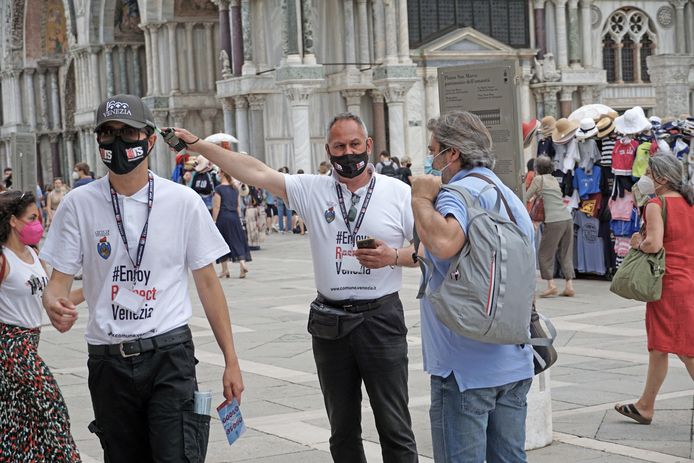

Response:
(438, 60), (524, 196)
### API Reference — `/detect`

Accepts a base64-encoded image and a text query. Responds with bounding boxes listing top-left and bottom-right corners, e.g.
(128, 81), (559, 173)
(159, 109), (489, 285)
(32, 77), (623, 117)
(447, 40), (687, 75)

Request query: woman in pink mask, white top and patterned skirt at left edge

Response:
(0, 191), (81, 462)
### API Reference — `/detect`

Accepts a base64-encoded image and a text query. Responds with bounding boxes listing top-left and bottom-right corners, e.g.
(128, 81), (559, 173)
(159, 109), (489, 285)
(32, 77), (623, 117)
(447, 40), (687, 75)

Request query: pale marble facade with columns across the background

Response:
(0, 0), (694, 188)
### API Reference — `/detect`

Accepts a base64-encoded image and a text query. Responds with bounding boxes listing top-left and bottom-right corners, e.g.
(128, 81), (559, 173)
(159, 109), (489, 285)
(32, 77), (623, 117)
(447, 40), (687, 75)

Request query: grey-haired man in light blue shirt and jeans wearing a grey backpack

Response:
(412, 111), (535, 463)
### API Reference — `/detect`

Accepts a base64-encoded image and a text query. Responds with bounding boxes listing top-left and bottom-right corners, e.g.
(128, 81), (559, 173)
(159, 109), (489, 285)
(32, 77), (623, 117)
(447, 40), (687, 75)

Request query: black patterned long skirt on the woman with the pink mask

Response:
(0, 323), (81, 462)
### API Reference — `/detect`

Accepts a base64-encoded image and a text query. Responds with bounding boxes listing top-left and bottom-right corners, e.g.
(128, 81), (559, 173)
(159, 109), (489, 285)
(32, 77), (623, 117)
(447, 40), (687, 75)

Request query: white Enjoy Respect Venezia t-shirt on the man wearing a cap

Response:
(41, 171), (229, 344)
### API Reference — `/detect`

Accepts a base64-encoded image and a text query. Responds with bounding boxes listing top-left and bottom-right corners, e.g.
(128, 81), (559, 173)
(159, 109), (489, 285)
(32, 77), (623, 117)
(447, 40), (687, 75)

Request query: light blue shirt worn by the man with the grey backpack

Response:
(420, 167), (535, 392)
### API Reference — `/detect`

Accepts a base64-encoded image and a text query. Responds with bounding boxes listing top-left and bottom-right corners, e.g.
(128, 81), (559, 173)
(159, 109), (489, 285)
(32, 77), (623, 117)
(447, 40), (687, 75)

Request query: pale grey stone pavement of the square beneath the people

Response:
(39, 235), (694, 463)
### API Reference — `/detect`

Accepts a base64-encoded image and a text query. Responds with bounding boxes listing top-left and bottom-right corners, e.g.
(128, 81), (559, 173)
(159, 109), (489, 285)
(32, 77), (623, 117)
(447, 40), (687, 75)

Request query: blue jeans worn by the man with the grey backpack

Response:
(429, 373), (532, 463)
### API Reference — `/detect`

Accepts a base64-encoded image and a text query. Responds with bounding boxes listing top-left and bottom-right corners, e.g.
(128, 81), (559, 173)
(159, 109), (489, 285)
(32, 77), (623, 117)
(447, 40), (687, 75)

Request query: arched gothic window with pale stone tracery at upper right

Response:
(602, 7), (656, 83)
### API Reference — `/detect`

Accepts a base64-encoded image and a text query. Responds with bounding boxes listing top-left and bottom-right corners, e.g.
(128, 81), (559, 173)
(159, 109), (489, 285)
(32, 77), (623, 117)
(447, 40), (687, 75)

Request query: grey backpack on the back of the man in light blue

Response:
(415, 174), (555, 346)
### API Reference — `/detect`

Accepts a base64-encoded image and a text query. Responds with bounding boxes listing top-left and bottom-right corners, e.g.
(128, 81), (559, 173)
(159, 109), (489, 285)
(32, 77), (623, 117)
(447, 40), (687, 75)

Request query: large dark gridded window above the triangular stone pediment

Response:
(407, 0), (530, 48)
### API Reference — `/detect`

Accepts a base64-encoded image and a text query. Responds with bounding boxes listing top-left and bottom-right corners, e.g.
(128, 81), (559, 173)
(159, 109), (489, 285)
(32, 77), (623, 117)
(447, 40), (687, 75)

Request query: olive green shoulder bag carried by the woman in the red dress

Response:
(610, 196), (667, 302)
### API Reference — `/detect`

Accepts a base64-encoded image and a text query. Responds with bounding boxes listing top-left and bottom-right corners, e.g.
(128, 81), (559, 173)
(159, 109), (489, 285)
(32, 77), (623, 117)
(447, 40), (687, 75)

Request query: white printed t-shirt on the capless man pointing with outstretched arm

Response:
(284, 169), (414, 300)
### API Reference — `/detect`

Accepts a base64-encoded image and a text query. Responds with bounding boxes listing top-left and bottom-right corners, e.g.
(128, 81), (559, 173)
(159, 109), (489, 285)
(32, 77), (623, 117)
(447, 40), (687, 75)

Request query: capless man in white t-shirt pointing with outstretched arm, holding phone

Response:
(176, 113), (417, 463)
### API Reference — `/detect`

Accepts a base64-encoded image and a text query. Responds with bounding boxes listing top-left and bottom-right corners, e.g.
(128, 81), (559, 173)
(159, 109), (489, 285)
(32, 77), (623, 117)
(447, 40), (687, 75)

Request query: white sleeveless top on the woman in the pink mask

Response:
(0, 248), (48, 328)
